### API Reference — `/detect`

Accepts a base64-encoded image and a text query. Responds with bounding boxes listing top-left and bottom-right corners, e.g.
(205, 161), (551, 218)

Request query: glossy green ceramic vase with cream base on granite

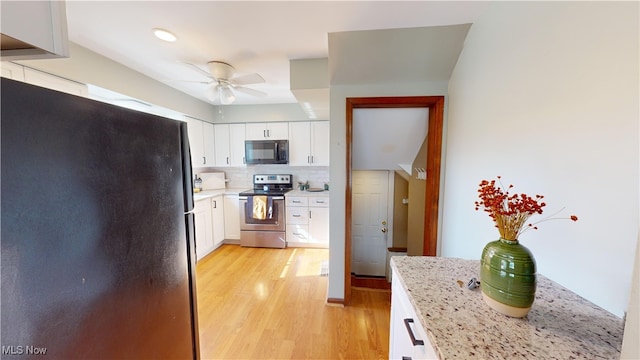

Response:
(480, 238), (536, 317)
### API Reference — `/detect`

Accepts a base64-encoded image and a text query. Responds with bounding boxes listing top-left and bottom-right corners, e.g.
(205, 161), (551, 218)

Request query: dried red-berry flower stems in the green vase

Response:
(475, 176), (578, 241)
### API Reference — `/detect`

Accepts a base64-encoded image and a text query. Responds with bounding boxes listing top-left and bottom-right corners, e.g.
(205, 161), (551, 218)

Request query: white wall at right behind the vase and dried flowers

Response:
(441, 2), (640, 316)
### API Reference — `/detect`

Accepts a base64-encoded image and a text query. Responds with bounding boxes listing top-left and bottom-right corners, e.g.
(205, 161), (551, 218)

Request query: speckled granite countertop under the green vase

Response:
(391, 256), (624, 360)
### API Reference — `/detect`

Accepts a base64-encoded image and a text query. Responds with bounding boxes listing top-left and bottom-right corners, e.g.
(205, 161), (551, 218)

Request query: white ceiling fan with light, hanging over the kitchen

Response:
(185, 61), (267, 105)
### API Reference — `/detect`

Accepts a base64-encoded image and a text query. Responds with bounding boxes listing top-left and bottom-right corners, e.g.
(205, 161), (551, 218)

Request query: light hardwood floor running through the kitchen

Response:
(196, 245), (391, 359)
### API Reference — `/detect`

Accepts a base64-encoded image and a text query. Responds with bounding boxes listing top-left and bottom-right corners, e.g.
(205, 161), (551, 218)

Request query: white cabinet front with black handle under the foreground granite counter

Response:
(389, 271), (438, 360)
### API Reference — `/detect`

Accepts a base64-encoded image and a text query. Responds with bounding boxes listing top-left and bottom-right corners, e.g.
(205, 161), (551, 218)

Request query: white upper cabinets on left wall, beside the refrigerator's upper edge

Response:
(185, 116), (215, 168)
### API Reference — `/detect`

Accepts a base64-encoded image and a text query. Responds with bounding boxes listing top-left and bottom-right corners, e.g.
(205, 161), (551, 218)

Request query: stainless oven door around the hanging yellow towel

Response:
(239, 196), (285, 231)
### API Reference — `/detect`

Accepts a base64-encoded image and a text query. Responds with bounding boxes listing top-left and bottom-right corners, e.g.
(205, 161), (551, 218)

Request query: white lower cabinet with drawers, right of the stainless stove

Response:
(285, 196), (329, 248)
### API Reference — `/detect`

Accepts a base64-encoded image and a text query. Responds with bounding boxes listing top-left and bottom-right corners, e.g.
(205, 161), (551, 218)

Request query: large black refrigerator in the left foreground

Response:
(0, 79), (199, 359)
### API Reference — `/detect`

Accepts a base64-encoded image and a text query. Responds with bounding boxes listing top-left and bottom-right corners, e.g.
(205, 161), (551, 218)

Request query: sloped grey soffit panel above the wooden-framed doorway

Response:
(329, 24), (471, 85)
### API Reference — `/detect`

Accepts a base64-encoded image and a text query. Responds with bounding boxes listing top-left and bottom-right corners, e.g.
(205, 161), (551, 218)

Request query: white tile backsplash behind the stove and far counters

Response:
(193, 165), (329, 189)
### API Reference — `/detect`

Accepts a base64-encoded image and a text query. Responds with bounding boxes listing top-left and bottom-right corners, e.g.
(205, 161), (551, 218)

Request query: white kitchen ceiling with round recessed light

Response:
(66, 0), (487, 104)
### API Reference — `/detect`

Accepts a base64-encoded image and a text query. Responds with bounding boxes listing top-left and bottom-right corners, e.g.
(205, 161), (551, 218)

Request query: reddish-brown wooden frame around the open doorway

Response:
(344, 96), (444, 305)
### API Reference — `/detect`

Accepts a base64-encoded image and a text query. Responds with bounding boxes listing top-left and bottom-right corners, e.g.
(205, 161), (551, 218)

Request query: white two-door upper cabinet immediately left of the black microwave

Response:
(214, 124), (245, 167)
